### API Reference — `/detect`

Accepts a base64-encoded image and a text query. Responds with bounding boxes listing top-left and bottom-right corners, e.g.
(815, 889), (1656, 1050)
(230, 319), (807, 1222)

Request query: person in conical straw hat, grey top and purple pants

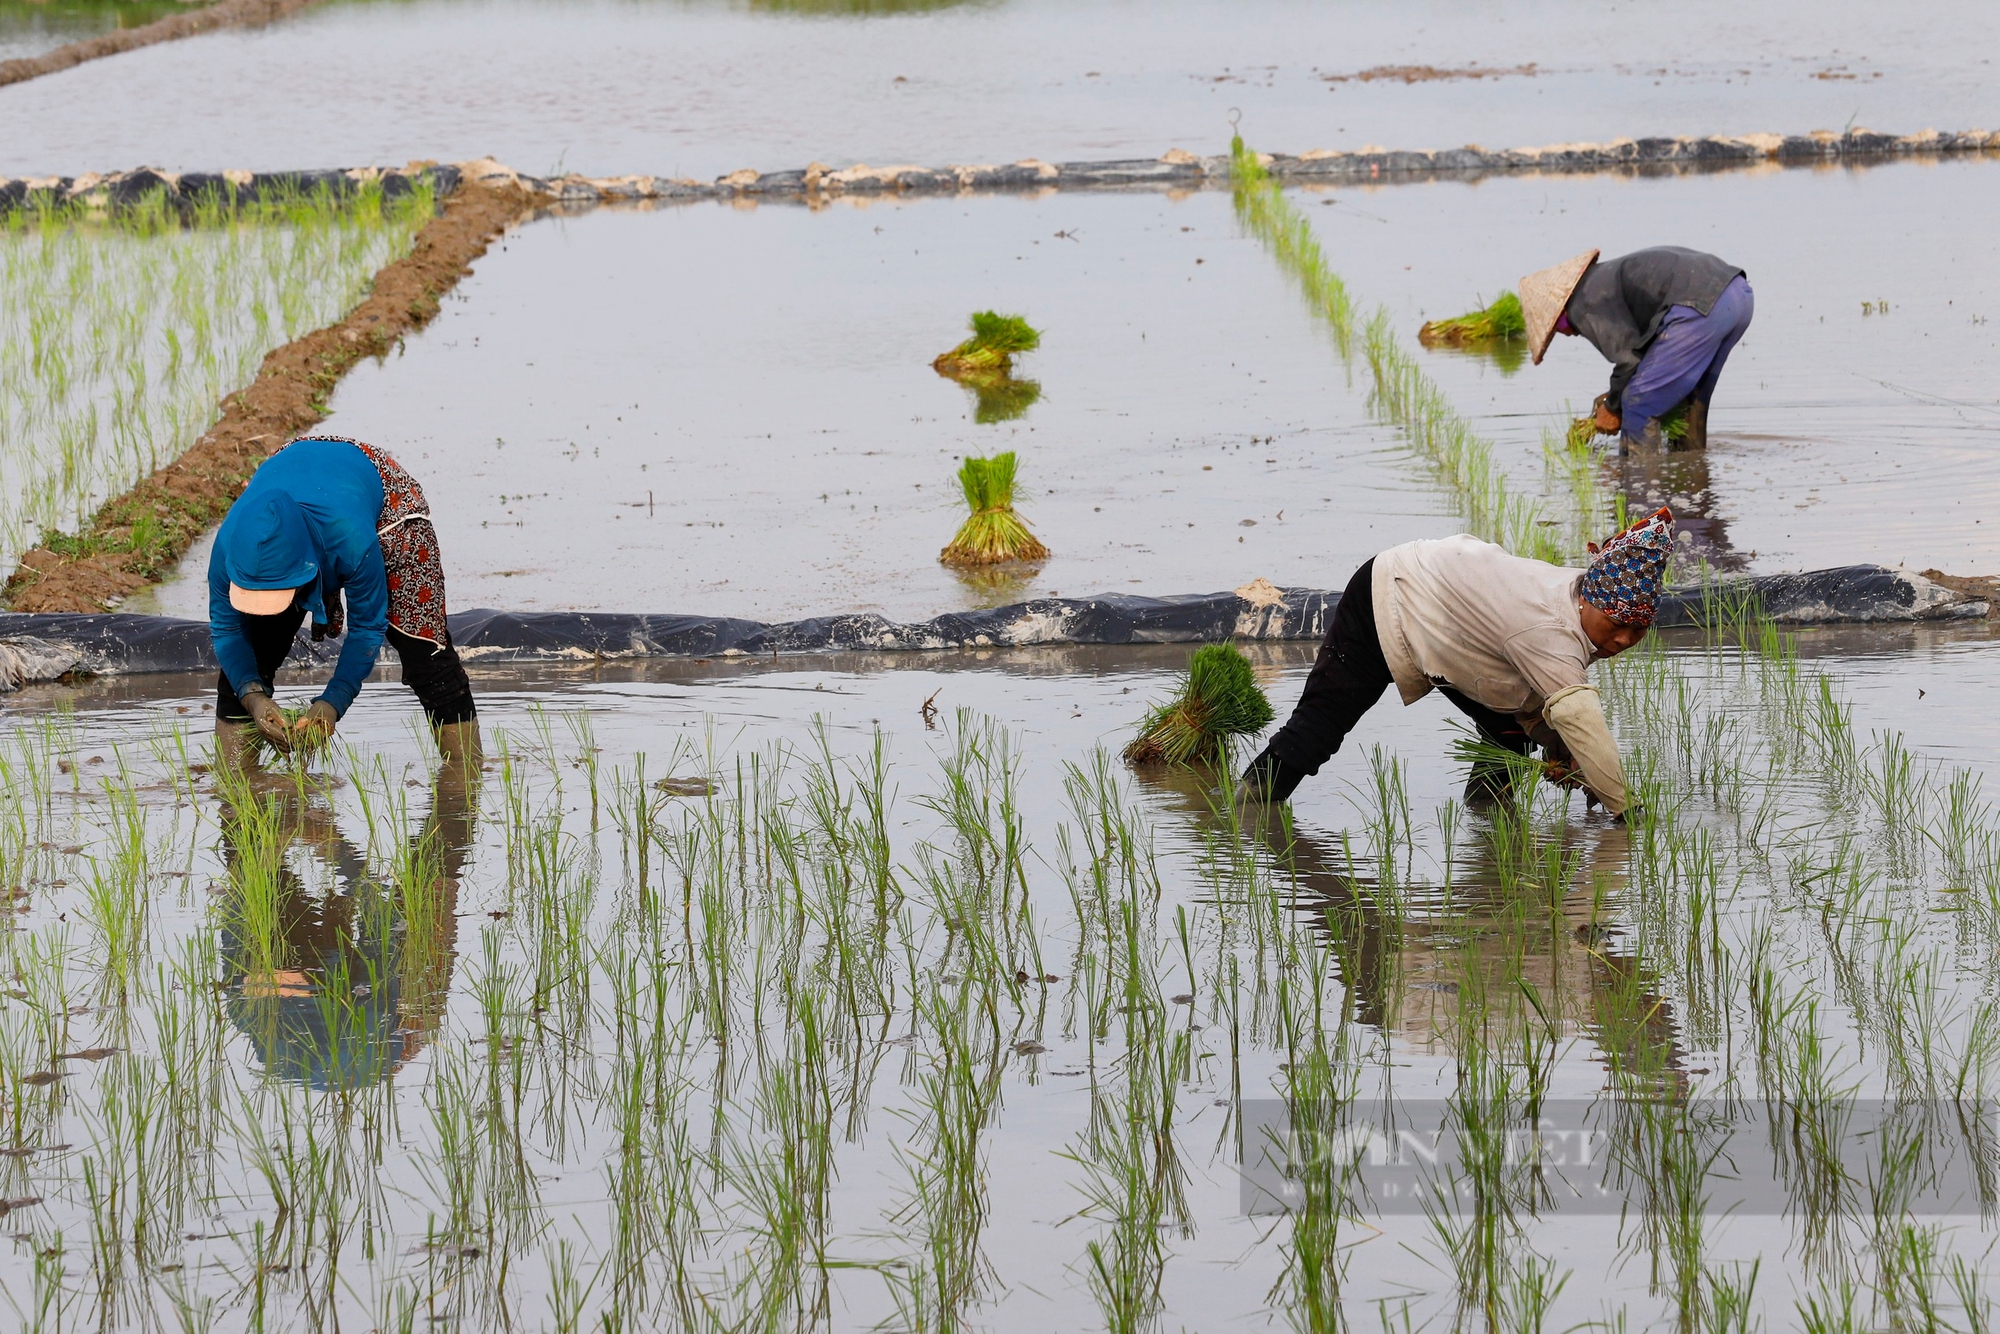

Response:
(1520, 246), (1756, 450)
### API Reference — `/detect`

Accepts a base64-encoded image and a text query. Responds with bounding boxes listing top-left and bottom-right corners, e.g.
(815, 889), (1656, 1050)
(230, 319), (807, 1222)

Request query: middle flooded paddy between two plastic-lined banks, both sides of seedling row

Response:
(121, 149), (2000, 618)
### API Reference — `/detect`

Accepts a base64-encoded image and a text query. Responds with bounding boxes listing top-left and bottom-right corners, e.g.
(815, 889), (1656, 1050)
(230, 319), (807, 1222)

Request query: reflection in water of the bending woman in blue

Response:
(216, 758), (480, 1088)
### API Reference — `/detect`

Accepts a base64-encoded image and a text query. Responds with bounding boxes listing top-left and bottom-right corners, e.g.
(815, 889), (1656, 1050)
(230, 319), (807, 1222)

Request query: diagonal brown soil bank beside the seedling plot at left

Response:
(0, 182), (536, 612)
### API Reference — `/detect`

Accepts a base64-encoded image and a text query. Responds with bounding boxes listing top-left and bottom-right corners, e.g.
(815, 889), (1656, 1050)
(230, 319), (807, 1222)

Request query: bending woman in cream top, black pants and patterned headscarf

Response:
(1244, 508), (1674, 816)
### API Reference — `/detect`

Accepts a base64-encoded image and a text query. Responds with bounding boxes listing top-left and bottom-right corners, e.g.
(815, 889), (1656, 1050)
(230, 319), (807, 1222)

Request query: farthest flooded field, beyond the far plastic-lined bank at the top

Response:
(0, 0), (2000, 176)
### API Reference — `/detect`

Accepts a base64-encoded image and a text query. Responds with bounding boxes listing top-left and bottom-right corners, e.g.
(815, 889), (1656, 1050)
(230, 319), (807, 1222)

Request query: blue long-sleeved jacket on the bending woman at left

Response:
(208, 440), (388, 716)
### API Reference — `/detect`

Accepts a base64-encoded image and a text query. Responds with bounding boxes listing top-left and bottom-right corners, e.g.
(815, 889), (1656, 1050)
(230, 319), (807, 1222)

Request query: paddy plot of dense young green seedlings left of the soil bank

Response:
(0, 190), (432, 574)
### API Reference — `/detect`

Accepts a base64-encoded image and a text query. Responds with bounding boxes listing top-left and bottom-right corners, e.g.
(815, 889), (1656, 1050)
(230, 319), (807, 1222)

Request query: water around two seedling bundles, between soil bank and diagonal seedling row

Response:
(137, 185), (1454, 618)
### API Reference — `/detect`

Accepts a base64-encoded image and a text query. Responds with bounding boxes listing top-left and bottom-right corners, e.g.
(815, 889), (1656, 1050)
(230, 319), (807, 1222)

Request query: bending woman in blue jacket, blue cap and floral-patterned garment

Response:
(208, 436), (478, 758)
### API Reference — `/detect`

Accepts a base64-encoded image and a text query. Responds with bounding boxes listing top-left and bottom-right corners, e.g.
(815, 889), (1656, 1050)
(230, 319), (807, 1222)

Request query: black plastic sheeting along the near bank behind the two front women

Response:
(0, 566), (1986, 690)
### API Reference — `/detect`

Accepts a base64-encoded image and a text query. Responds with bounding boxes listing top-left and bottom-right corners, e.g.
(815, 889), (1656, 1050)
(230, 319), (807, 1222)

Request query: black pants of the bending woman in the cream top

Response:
(1252, 560), (1534, 794)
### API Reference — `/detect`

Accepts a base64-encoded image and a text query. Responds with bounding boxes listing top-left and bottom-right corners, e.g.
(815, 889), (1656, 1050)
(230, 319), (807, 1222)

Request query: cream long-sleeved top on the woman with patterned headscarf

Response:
(1372, 534), (1626, 814)
